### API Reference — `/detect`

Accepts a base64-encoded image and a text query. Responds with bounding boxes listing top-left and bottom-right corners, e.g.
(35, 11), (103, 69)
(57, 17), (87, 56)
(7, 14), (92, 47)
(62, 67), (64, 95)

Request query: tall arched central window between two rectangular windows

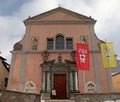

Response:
(55, 35), (64, 50)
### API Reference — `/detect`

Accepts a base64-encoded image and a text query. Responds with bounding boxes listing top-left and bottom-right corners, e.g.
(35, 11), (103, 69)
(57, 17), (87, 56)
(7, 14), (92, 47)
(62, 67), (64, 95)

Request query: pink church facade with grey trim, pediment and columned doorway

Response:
(7, 7), (113, 99)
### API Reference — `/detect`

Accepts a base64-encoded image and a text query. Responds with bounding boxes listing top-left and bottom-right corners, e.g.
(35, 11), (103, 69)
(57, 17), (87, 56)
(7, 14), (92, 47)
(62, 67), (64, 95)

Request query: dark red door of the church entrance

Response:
(54, 74), (67, 99)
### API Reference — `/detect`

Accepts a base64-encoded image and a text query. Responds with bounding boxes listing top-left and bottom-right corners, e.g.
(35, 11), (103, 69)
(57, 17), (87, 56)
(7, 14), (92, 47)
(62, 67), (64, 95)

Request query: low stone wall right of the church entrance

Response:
(75, 93), (120, 102)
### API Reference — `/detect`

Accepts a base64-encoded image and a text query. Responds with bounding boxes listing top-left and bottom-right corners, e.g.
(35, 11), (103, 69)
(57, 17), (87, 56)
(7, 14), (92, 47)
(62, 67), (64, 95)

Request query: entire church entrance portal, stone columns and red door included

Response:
(41, 56), (79, 99)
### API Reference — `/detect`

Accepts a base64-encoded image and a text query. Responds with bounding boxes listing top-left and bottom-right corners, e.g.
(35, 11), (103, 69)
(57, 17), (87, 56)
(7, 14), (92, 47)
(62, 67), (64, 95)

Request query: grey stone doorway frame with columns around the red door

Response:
(41, 57), (79, 99)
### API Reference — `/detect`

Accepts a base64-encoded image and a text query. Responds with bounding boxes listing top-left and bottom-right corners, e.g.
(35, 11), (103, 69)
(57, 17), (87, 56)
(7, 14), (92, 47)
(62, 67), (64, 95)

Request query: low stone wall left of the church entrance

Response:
(0, 90), (41, 102)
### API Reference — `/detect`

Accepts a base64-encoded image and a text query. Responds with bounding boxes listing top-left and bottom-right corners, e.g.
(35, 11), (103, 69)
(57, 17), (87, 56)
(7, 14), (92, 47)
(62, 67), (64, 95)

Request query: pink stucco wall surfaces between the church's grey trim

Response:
(9, 7), (109, 92)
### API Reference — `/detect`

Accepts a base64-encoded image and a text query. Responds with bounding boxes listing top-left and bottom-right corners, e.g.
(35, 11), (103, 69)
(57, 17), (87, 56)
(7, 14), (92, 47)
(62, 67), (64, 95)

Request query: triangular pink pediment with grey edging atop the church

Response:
(27, 7), (94, 21)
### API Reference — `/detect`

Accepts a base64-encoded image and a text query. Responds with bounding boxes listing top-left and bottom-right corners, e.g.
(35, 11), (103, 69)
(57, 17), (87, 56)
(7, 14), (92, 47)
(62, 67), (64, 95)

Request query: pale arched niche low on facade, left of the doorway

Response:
(25, 81), (36, 93)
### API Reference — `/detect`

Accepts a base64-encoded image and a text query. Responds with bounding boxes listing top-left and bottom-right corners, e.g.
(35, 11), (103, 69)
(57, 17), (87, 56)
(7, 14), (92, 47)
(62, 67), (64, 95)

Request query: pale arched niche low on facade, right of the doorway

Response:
(86, 81), (96, 93)
